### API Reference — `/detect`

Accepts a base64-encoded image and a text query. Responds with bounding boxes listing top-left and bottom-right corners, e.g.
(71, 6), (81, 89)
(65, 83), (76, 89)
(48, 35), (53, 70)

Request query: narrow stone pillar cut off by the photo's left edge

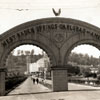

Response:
(0, 68), (6, 96)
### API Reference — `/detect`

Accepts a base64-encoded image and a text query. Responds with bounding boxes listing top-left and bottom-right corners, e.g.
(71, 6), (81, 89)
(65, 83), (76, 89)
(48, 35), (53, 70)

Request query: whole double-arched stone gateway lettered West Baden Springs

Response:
(0, 18), (100, 95)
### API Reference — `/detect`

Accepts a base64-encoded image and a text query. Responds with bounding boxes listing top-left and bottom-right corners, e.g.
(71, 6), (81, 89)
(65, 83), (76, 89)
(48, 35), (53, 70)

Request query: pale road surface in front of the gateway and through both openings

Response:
(0, 78), (100, 100)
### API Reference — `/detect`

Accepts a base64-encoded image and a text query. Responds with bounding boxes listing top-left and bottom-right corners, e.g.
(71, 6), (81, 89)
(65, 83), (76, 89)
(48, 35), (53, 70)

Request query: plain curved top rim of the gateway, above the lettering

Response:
(0, 17), (100, 39)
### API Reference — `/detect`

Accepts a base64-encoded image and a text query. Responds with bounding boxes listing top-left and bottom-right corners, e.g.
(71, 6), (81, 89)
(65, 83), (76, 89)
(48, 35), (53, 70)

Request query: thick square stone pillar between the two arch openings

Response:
(51, 66), (68, 92)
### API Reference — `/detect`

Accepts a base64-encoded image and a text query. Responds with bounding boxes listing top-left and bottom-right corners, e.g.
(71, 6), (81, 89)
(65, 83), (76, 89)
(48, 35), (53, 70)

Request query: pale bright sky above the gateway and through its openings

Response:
(0, 0), (100, 57)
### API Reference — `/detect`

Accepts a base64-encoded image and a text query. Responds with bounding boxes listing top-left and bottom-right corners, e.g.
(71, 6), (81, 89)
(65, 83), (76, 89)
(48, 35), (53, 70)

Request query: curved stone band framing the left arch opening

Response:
(1, 39), (56, 66)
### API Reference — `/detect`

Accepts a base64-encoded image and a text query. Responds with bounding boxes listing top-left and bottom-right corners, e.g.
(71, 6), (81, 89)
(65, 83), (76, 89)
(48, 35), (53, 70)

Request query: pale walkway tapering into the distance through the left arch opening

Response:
(8, 77), (51, 96)
